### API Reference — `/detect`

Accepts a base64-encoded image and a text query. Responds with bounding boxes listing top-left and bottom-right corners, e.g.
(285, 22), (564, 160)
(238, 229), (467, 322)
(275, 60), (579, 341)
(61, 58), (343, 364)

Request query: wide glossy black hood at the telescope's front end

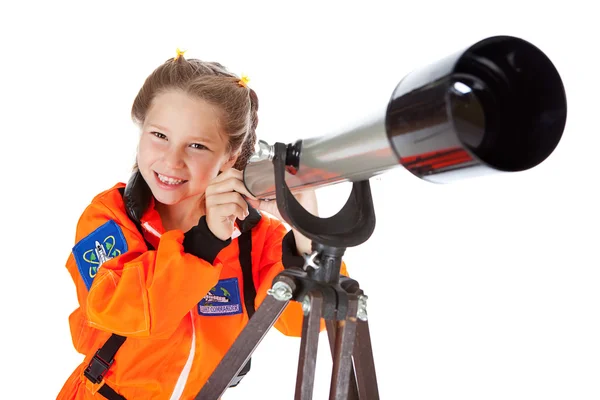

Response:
(385, 36), (567, 178)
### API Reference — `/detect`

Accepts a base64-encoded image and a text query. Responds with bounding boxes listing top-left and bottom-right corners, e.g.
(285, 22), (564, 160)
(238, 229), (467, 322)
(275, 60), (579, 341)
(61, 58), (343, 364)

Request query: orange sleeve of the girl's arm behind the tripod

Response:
(255, 220), (348, 337)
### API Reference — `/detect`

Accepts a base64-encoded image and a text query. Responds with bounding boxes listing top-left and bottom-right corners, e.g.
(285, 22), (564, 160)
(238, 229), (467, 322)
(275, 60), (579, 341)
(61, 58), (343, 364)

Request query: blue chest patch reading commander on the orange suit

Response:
(198, 278), (243, 316)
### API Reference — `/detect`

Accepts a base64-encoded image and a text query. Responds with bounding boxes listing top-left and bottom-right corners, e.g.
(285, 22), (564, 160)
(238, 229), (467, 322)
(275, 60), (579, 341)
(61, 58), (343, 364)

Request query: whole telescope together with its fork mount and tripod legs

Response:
(196, 36), (567, 400)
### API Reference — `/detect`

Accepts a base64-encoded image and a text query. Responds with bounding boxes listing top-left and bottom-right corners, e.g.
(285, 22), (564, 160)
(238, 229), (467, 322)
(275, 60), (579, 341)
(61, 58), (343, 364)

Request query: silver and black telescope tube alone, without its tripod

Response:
(243, 36), (567, 199)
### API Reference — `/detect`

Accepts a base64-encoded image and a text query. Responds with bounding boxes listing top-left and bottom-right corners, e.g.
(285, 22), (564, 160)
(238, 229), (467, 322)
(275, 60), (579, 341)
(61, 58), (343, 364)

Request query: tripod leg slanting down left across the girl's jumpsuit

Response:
(195, 296), (289, 400)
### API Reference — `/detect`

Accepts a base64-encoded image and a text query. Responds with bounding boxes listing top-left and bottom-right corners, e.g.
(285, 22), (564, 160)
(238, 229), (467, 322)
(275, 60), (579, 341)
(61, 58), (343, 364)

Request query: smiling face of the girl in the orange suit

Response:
(137, 90), (235, 205)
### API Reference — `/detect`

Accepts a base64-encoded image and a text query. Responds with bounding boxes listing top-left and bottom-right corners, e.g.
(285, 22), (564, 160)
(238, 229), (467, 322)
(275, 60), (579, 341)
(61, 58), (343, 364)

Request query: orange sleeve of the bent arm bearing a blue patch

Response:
(67, 200), (222, 337)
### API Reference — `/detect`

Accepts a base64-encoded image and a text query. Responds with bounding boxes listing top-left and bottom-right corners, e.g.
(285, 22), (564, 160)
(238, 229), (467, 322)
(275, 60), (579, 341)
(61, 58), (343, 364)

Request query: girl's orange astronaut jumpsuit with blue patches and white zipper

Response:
(57, 183), (346, 400)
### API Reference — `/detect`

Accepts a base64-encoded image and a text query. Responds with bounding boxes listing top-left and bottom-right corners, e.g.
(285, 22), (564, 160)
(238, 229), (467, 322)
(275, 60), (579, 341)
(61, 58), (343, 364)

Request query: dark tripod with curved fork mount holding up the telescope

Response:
(196, 143), (379, 400)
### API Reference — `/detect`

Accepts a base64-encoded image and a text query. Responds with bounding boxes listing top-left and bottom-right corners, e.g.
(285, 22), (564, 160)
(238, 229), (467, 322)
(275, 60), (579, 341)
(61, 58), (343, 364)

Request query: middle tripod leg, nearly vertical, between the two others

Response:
(294, 291), (323, 400)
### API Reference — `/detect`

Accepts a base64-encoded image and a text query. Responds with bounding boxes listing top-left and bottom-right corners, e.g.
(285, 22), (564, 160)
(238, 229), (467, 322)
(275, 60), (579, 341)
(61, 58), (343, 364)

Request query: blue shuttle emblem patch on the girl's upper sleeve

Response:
(73, 220), (127, 290)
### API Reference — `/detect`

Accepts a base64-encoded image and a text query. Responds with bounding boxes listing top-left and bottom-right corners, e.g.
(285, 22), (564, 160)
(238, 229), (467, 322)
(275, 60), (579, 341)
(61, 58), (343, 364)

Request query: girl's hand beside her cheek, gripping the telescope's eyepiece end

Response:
(205, 168), (256, 240)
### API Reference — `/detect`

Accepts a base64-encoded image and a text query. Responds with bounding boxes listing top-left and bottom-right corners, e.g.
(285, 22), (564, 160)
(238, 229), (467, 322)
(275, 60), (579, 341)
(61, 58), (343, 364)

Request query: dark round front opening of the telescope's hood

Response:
(455, 37), (567, 171)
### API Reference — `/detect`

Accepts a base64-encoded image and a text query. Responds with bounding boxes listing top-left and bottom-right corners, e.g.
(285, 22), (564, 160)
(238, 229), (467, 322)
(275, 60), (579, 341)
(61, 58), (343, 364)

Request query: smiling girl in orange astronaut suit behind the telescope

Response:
(58, 50), (345, 400)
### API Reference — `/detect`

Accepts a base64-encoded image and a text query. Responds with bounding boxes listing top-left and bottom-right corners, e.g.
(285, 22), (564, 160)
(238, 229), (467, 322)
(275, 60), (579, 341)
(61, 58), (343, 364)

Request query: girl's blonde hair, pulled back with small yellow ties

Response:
(131, 56), (258, 170)
